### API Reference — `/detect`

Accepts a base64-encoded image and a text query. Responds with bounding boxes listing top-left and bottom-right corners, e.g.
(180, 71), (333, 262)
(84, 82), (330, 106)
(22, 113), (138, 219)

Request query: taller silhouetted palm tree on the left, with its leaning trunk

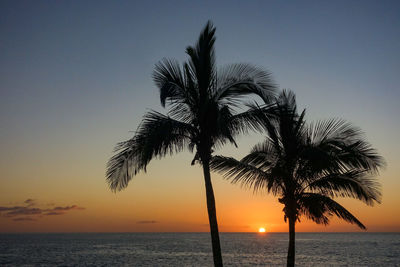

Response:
(106, 22), (276, 266)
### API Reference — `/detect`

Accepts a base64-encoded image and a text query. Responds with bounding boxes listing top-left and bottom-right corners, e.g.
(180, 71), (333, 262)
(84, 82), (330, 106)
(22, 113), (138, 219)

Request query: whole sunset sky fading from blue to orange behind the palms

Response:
(0, 0), (400, 232)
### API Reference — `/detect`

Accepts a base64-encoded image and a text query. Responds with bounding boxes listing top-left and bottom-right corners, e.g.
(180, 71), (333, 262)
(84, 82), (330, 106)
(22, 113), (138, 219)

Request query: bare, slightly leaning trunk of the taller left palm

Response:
(203, 161), (223, 267)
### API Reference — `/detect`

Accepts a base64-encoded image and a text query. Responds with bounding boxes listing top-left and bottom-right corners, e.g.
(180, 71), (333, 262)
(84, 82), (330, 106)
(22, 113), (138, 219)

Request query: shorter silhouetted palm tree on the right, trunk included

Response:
(210, 91), (384, 266)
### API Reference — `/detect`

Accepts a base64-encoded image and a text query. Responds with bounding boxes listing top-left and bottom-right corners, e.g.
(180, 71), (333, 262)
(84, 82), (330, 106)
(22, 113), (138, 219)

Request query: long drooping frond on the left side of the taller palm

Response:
(106, 111), (195, 191)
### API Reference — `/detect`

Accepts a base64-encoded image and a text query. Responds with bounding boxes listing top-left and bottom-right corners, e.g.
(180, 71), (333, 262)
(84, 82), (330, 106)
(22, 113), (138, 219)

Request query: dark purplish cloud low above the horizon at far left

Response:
(0, 198), (85, 222)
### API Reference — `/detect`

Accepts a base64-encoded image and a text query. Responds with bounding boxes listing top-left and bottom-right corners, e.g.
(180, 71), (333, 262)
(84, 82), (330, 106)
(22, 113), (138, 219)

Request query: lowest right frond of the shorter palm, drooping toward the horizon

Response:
(299, 193), (366, 229)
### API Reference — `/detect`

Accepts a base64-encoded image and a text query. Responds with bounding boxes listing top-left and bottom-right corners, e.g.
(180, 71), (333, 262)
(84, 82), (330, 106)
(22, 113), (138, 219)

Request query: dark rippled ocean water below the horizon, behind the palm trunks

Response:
(0, 233), (400, 267)
